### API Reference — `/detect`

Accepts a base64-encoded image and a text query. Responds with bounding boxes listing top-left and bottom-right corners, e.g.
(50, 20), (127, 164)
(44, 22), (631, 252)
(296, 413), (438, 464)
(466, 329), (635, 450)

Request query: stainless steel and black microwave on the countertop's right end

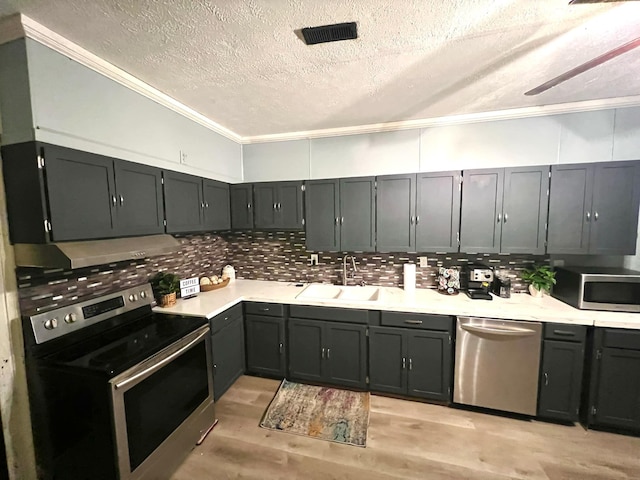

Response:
(551, 267), (640, 312)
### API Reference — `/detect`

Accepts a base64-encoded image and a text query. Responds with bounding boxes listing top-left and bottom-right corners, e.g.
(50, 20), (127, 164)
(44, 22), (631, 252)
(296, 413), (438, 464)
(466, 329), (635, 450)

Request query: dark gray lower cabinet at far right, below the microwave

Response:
(586, 328), (640, 432)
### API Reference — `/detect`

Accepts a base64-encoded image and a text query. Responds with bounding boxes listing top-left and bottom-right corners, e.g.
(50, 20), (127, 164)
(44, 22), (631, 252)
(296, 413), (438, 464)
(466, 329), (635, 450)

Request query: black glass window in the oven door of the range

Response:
(124, 340), (209, 472)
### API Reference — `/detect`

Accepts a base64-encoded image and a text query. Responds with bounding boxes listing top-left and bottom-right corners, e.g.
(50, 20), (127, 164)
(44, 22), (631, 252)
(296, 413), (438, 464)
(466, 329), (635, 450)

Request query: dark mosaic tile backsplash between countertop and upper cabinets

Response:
(16, 232), (549, 315)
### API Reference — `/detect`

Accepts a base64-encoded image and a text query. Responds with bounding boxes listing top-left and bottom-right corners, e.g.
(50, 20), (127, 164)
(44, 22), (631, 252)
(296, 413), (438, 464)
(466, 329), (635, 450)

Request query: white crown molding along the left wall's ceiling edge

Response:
(7, 14), (242, 143)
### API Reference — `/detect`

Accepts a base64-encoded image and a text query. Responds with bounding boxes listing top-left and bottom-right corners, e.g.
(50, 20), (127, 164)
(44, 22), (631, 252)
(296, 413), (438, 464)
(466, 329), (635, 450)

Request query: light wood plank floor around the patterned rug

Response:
(172, 376), (640, 480)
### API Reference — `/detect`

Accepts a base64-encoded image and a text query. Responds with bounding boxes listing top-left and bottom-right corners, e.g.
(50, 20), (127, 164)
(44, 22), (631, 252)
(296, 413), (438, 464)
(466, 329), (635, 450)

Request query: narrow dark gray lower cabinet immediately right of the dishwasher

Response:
(538, 323), (586, 422)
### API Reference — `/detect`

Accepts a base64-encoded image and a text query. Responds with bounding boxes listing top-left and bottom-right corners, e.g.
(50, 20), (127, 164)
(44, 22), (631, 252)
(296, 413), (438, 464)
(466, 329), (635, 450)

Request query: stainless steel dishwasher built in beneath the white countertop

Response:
(453, 317), (542, 415)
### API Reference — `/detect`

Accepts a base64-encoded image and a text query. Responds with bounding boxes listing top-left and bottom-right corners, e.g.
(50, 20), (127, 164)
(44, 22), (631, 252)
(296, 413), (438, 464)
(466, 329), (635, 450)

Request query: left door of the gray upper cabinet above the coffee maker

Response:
(460, 168), (504, 253)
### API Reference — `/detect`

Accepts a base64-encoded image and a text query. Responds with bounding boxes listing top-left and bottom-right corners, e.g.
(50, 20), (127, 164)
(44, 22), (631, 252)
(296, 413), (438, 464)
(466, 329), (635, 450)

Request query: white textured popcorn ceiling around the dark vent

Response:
(0, 0), (640, 136)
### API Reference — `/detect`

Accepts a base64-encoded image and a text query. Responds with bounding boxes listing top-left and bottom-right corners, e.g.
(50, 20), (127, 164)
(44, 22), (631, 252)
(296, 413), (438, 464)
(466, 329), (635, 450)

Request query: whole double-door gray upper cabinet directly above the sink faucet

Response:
(305, 177), (375, 252)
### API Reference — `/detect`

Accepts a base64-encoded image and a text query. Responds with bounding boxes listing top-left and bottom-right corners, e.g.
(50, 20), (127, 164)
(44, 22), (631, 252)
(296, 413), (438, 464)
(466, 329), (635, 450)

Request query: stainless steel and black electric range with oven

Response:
(23, 284), (215, 480)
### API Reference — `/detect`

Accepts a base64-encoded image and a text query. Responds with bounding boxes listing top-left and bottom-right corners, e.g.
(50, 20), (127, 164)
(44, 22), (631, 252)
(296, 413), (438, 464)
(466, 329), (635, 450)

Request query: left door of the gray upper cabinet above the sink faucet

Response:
(305, 180), (340, 252)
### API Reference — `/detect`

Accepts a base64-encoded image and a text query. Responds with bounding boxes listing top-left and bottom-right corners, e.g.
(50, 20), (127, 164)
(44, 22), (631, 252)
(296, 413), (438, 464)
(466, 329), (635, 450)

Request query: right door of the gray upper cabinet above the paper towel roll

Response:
(415, 170), (462, 253)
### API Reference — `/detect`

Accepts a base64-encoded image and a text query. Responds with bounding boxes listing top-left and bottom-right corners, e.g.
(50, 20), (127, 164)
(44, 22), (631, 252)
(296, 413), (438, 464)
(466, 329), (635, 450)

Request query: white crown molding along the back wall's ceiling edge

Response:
(242, 95), (640, 144)
